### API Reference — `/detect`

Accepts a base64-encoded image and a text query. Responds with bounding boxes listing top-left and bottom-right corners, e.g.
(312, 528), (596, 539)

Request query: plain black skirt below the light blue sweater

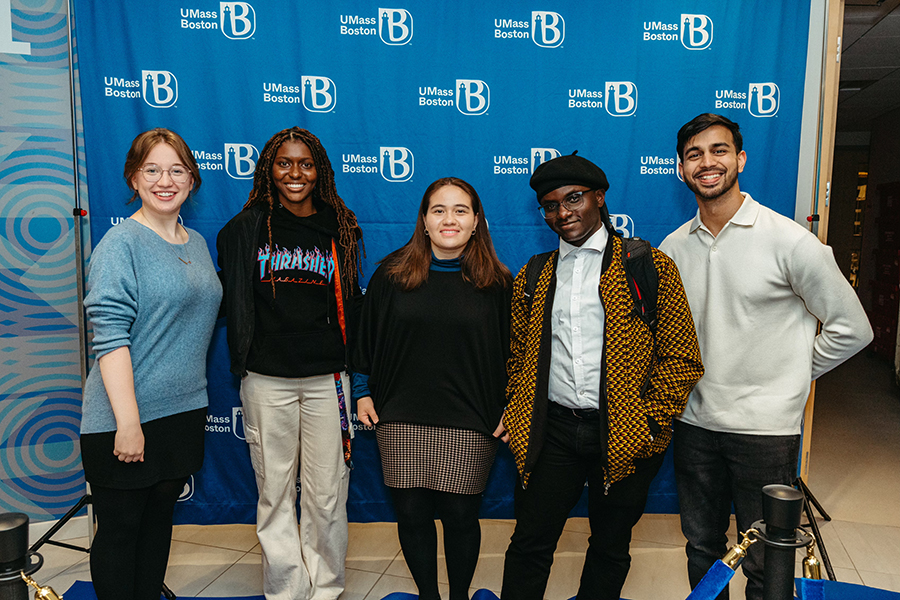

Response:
(81, 408), (206, 490)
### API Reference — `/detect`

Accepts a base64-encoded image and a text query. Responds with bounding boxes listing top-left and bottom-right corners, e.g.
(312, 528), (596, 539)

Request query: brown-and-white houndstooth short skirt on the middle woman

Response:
(375, 423), (497, 494)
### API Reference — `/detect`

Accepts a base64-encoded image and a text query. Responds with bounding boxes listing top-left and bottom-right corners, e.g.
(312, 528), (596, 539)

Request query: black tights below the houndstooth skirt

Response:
(390, 488), (481, 600)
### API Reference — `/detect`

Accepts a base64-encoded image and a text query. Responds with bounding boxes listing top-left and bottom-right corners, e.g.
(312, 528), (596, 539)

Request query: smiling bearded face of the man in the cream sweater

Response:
(678, 125), (747, 201)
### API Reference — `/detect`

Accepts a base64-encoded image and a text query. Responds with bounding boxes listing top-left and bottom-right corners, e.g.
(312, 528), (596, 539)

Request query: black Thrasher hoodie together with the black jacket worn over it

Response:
(216, 205), (359, 377)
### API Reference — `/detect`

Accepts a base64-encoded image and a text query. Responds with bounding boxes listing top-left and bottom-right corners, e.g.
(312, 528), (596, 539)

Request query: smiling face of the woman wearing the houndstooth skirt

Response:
(423, 185), (478, 260)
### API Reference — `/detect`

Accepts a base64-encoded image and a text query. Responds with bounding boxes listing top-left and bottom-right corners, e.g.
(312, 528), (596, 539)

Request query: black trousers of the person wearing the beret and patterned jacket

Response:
(500, 403), (663, 600)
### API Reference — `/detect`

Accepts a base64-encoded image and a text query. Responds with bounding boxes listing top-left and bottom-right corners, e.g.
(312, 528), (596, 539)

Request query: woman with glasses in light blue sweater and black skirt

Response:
(81, 128), (222, 600)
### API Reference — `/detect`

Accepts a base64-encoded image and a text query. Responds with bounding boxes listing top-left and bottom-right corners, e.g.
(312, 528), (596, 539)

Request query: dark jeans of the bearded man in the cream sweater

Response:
(673, 421), (800, 600)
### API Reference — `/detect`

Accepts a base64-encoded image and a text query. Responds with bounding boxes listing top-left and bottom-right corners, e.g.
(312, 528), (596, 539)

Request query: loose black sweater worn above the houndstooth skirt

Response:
(357, 267), (510, 435)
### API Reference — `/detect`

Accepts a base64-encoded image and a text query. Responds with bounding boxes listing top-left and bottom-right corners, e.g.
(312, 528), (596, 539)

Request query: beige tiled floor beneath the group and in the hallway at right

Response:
(38, 356), (900, 600)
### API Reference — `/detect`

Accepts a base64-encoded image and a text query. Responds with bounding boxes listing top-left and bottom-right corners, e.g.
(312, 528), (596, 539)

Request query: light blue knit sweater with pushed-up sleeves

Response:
(81, 219), (222, 433)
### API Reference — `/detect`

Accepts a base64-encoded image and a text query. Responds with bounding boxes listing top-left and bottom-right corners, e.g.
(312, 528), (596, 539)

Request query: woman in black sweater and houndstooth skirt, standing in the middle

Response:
(357, 177), (512, 600)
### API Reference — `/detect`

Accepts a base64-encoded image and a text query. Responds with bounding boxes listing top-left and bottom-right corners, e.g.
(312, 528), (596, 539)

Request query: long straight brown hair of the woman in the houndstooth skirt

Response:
(381, 177), (512, 291)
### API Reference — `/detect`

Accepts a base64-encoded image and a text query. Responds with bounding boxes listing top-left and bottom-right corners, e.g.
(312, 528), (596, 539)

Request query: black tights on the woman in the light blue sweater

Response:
(91, 479), (185, 600)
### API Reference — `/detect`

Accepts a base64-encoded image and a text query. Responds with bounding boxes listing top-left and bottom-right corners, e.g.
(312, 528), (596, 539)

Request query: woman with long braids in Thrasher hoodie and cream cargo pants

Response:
(216, 127), (362, 600)
